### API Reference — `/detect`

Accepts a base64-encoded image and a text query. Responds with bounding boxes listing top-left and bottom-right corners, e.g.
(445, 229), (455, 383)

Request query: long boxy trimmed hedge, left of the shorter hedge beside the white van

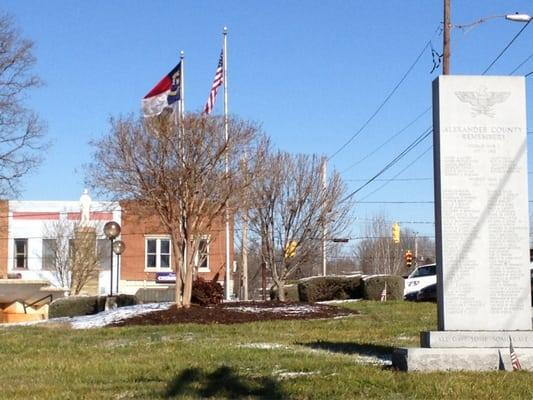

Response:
(298, 276), (363, 302)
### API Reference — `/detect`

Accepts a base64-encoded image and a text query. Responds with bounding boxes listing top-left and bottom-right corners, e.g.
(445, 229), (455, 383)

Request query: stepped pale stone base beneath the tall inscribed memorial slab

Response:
(392, 331), (533, 372)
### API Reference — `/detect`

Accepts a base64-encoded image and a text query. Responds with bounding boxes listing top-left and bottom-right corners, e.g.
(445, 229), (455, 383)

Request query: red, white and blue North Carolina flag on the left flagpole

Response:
(142, 61), (181, 117)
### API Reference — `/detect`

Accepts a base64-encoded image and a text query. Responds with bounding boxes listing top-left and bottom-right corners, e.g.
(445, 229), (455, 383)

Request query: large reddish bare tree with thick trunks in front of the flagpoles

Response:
(88, 114), (264, 307)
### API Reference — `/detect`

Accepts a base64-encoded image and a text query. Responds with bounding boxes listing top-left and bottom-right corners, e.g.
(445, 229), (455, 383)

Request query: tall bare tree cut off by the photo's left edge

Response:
(0, 13), (45, 196)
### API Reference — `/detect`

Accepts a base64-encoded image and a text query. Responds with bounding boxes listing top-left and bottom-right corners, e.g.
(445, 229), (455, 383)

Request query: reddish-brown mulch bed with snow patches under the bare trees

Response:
(112, 302), (358, 326)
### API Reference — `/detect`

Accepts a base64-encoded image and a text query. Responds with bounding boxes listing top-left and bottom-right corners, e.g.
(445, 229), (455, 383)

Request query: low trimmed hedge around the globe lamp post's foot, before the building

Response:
(48, 294), (138, 318)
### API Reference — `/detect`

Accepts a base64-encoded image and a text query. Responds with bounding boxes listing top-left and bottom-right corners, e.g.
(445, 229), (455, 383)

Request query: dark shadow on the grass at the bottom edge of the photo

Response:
(165, 366), (285, 400)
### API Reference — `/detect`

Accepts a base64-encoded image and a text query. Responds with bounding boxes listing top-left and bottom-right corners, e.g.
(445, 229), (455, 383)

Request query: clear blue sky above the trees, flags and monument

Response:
(0, 0), (533, 241)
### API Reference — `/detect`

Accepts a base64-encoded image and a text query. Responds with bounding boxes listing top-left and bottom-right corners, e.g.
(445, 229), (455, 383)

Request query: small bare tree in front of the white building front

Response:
(43, 220), (105, 295)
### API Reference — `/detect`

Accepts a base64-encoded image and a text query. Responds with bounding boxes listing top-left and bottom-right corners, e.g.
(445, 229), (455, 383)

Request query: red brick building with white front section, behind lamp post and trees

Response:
(0, 192), (233, 294)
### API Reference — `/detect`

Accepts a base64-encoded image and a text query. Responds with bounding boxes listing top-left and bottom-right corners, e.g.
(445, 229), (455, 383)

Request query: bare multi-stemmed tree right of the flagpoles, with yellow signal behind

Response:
(250, 152), (350, 301)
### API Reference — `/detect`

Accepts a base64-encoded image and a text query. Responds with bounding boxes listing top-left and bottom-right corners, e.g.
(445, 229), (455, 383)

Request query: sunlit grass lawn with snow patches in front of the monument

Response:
(0, 302), (533, 400)
